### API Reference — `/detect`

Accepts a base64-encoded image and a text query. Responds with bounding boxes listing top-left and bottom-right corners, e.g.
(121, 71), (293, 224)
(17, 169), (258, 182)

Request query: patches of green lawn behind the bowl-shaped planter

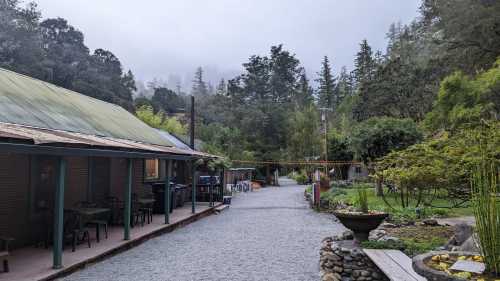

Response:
(322, 185), (473, 221)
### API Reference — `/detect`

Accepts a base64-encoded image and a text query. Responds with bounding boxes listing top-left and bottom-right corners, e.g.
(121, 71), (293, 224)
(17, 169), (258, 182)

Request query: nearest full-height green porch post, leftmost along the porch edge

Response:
(52, 157), (66, 269)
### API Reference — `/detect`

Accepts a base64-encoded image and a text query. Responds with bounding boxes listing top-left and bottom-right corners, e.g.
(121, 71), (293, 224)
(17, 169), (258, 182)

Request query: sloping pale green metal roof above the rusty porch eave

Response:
(0, 68), (173, 146)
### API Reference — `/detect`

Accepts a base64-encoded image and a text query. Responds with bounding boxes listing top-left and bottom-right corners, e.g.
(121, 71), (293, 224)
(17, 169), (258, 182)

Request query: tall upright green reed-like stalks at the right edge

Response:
(471, 161), (500, 275)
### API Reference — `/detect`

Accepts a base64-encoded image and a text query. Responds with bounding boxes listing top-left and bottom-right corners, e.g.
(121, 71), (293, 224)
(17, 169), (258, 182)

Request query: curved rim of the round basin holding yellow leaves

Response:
(412, 251), (493, 281)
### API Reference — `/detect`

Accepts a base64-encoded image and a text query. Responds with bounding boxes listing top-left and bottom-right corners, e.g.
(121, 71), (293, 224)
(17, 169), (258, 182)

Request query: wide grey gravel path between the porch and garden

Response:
(63, 179), (343, 281)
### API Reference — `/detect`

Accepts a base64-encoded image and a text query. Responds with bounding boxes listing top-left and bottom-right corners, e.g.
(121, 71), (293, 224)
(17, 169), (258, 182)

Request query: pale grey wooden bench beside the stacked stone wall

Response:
(363, 249), (427, 281)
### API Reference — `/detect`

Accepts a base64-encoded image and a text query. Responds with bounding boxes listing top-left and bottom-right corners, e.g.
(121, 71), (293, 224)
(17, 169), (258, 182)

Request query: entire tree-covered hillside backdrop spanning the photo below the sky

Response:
(0, 0), (500, 162)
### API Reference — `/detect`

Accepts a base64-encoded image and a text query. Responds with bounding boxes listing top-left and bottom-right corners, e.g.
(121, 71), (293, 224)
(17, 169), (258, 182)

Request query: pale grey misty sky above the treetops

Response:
(35, 0), (420, 87)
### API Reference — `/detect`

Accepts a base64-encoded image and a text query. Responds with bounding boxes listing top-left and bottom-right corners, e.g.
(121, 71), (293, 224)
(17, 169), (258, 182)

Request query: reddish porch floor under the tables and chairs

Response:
(0, 202), (220, 281)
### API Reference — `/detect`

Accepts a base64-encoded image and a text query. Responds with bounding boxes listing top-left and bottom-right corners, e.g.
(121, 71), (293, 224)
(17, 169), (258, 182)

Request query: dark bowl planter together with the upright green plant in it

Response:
(334, 185), (388, 243)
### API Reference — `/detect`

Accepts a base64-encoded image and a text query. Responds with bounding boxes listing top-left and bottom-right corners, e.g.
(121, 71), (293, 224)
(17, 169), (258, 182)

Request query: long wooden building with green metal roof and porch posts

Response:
(0, 66), (220, 268)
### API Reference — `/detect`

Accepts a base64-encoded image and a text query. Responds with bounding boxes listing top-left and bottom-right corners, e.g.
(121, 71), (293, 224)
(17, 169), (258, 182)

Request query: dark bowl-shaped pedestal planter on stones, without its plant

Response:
(333, 212), (388, 242)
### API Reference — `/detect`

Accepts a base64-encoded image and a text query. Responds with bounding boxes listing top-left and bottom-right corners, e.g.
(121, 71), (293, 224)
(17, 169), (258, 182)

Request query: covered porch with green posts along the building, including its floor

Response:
(0, 125), (223, 280)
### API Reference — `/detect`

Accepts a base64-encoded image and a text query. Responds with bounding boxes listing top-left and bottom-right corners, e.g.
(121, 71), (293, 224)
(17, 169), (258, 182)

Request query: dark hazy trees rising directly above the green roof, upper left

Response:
(0, 0), (135, 111)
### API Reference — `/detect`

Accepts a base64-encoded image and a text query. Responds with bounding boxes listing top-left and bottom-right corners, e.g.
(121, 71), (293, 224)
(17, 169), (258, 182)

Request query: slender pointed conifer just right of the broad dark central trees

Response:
(316, 56), (336, 108)
